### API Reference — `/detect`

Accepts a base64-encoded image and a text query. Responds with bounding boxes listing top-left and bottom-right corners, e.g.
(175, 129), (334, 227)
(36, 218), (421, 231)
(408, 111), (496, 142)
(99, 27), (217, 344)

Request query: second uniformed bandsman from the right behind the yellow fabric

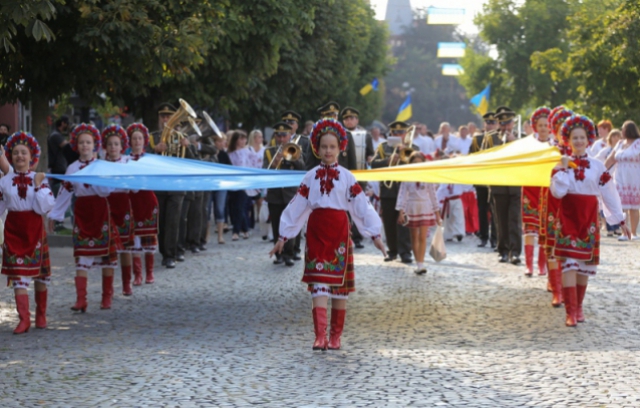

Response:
(469, 112), (500, 248)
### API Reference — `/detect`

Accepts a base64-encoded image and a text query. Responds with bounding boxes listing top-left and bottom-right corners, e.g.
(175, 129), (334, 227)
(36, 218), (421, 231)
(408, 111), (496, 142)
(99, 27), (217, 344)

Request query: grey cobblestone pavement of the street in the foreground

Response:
(0, 231), (640, 407)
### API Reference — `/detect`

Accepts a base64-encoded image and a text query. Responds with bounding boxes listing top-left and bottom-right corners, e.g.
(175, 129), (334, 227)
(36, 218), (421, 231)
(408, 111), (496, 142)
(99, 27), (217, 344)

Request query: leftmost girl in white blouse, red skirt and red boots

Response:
(0, 132), (55, 334)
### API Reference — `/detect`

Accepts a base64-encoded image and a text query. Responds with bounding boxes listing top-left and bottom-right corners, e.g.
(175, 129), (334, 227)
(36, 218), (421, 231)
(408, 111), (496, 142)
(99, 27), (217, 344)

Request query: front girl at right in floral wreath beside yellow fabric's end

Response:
(550, 115), (630, 327)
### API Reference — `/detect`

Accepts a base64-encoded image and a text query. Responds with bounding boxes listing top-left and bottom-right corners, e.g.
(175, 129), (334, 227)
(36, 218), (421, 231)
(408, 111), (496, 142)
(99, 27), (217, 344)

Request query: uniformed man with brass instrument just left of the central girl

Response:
(262, 122), (304, 266)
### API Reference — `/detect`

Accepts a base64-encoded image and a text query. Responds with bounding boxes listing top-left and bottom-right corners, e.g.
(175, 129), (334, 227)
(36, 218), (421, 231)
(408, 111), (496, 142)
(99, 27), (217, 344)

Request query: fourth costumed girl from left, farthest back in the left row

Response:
(127, 123), (158, 286)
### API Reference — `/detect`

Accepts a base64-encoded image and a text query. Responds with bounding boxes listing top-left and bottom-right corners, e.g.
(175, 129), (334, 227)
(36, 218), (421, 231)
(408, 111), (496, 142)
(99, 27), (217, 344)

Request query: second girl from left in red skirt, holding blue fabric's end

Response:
(49, 123), (119, 313)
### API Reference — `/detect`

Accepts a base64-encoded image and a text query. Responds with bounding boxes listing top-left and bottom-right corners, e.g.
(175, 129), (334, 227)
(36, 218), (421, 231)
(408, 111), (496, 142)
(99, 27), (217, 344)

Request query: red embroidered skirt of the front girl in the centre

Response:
(302, 208), (356, 293)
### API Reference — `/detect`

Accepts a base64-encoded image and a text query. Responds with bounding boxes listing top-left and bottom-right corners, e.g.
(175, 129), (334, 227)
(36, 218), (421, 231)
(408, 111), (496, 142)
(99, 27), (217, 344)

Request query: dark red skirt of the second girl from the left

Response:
(73, 195), (121, 257)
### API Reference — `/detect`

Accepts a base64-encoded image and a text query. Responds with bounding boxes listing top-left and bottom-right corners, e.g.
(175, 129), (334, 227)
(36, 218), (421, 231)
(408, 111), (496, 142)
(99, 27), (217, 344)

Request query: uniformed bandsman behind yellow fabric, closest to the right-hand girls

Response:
(491, 106), (522, 265)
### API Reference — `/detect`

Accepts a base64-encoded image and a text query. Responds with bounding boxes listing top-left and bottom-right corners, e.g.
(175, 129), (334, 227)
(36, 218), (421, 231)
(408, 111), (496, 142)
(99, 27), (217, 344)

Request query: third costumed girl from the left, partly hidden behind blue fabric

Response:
(102, 125), (133, 296)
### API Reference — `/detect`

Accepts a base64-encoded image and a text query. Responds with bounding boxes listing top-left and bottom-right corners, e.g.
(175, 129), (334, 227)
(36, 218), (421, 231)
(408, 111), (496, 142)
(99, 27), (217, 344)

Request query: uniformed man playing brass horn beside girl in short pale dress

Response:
(371, 121), (420, 263)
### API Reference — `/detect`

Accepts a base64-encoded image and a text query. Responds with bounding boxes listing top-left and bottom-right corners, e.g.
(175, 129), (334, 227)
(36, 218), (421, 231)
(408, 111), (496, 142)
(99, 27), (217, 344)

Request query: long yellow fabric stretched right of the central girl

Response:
(352, 136), (561, 187)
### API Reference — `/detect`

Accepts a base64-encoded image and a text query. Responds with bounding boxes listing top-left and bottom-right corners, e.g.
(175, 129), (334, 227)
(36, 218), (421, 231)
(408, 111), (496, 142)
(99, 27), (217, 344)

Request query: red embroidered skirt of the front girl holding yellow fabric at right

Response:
(554, 194), (600, 265)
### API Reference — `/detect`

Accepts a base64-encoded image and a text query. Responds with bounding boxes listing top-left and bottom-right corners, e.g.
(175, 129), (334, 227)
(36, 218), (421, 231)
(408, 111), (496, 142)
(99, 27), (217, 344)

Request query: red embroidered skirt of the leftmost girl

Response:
(2, 211), (51, 278)
